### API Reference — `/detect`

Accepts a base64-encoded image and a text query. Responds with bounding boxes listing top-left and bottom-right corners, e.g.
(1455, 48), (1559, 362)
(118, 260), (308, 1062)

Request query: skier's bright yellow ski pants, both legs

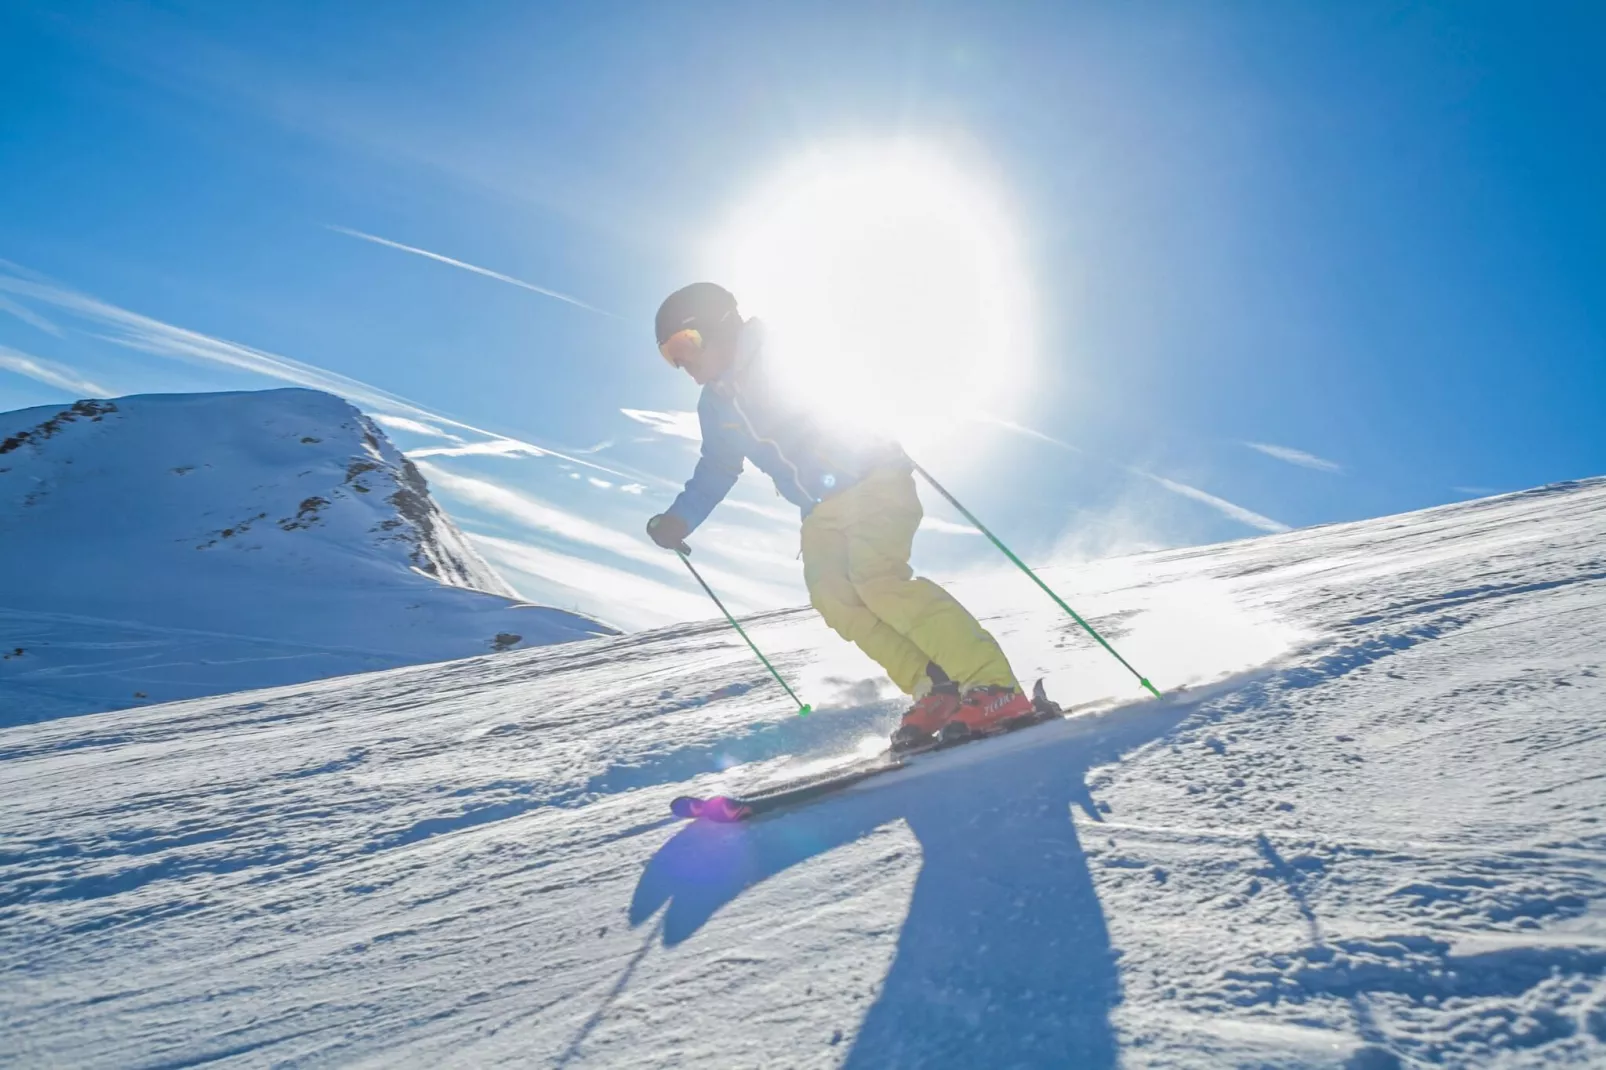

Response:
(803, 464), (1018, 694)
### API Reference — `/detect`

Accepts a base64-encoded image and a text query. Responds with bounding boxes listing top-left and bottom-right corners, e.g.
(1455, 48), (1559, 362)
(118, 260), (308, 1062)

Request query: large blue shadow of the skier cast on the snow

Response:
(630, 707), (1188, 1068)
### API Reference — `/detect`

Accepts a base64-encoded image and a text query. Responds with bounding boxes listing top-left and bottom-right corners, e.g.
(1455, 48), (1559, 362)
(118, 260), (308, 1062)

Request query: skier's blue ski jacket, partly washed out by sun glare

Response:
(668, 320), (907, 529)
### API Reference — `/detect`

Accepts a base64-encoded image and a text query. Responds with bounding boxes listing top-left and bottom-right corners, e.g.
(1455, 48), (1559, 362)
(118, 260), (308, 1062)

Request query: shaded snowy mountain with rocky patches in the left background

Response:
(0, 389), (610, 725)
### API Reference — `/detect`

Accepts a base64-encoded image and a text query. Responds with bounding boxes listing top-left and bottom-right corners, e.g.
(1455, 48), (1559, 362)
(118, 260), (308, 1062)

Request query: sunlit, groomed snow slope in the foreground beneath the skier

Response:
(0, 480), (1606, 1068)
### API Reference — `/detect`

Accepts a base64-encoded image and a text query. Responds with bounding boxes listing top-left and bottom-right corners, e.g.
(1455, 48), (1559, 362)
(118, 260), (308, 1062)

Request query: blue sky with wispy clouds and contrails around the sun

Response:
(0, 2), (1606, 627)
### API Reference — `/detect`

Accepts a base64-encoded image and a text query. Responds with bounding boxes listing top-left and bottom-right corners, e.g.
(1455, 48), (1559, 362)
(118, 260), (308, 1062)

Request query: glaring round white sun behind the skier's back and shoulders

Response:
(710, 145), (1031, 450)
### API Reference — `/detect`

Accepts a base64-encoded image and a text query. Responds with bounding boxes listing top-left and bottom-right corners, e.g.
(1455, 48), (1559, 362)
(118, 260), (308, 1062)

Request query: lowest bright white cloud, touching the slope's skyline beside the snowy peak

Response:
(469, 533), (718, 628)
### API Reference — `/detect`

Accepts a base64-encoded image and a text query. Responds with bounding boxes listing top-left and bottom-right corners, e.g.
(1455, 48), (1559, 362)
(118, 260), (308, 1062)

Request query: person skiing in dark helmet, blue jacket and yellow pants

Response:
(647, 283), (1033, 747)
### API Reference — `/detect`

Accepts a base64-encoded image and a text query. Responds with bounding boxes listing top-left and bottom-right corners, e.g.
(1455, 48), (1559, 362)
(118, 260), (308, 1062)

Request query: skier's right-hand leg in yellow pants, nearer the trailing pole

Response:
(842, 469), (1020, 689)
